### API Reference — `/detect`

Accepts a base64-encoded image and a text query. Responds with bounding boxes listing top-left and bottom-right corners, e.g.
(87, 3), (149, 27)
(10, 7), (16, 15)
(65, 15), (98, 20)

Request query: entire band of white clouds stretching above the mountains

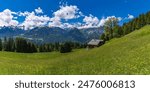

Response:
(0, 4), (127, 30)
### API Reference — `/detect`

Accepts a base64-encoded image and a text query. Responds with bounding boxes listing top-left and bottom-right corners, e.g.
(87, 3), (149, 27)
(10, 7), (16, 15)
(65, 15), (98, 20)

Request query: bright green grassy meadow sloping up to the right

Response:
(0, 26), (150, 74)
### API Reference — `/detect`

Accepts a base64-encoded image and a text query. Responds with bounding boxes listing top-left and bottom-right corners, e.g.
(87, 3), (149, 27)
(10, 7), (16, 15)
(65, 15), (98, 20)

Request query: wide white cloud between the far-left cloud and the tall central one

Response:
(20, 12), (50, 30)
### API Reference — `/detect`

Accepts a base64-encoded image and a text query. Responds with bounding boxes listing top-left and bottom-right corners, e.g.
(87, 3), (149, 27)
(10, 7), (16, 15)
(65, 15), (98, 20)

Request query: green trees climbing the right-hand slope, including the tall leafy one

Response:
(100, 12), (150, 41)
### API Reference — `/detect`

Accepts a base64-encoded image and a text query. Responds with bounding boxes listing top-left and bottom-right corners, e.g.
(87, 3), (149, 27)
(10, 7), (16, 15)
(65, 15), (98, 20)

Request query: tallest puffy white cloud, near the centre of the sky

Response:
(49, 5), (83, 28)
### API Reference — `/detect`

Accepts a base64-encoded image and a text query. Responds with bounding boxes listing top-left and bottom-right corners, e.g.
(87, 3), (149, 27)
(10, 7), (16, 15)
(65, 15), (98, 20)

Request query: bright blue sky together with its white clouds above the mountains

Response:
(0, 0), (150, 28)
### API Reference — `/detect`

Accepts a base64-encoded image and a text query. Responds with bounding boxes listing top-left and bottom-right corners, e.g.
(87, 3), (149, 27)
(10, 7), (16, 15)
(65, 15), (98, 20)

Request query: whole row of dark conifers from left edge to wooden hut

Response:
(0, 37), (86, 53)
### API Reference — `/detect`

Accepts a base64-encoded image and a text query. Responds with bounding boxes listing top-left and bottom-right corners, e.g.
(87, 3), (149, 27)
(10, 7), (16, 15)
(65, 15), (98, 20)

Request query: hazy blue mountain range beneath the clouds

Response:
(0, 27), (103, 43)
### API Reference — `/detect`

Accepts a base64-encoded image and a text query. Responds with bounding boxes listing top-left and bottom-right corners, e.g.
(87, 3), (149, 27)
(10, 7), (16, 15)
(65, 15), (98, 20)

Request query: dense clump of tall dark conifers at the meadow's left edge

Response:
(0, 37), (37, 53)
